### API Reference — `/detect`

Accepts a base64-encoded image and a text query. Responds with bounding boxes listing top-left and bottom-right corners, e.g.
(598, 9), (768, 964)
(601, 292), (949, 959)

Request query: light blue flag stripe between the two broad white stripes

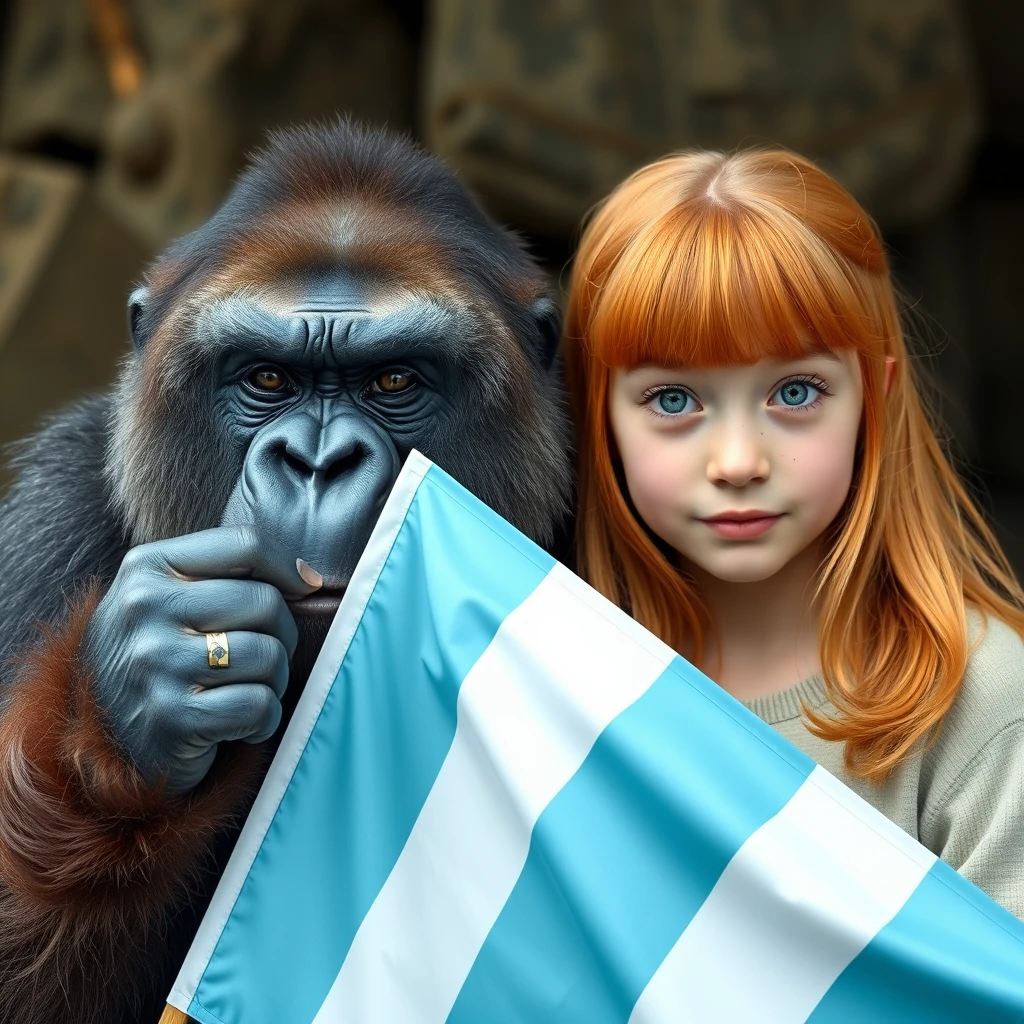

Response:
(447, 658), (814, 1024)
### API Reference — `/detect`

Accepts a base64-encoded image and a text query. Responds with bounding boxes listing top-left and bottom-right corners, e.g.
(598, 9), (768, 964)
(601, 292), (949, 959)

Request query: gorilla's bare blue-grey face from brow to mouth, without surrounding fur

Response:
(214, 272), (454, 615)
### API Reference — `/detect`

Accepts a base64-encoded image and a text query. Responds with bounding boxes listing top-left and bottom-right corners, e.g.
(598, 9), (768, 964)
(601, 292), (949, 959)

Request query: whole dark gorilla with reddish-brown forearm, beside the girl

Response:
(0, 121), (571, 1024)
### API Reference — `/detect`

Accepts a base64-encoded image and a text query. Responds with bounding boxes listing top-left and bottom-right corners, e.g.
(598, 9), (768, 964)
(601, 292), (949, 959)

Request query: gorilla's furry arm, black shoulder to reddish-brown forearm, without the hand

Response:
(0, 399), (268, 1024)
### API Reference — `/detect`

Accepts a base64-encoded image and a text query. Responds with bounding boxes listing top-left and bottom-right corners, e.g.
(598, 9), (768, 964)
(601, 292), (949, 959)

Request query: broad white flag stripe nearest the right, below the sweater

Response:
(630, 767), (936, 1024)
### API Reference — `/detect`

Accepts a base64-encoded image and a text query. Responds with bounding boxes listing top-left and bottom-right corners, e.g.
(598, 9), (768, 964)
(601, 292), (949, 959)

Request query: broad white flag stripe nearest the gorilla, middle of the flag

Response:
(314, 565), (674, 1024)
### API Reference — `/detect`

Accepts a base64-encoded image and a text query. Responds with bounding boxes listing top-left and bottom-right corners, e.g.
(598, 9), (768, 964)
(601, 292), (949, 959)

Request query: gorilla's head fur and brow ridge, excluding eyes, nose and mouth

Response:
(108, 121), (571, 561)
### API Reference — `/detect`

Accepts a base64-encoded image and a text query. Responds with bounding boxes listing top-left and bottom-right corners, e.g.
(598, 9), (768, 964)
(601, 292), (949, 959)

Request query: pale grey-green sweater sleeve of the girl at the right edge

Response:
(921, 709), (1024, 921)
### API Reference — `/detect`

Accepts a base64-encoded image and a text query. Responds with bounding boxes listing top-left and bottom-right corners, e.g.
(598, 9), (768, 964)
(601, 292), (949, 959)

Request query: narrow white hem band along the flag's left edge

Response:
(167, 450), (433, 1013)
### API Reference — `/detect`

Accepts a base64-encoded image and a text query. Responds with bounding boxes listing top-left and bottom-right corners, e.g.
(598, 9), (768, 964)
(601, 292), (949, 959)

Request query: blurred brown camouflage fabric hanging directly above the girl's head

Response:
(424, 0), (979, 236)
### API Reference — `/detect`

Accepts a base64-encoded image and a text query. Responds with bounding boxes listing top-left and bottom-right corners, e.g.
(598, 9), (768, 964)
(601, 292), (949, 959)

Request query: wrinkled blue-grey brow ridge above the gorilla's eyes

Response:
(196, 293), (475, 368)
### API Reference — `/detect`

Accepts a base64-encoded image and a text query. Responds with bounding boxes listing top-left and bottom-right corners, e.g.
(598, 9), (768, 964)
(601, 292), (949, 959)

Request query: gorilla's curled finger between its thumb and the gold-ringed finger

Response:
(176, 580), (299, 655)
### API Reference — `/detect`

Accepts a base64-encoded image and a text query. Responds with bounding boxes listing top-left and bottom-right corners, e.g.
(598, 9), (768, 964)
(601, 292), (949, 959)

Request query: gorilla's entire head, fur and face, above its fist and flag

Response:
(106, 123), (571, 684)
